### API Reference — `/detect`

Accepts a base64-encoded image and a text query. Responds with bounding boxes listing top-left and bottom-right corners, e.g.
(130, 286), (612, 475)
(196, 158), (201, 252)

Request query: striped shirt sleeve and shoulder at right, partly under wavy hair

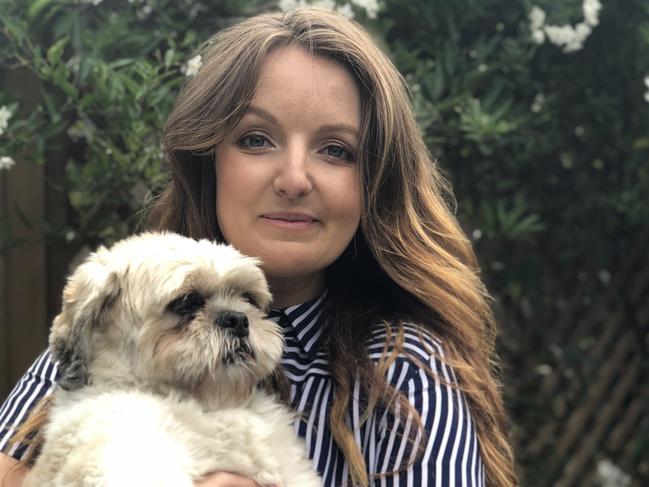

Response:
(366, 325), (485, 487)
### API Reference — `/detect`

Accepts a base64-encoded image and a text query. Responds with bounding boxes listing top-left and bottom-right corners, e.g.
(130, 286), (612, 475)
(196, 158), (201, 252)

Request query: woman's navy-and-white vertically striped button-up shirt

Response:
(0, 296), (485, 487)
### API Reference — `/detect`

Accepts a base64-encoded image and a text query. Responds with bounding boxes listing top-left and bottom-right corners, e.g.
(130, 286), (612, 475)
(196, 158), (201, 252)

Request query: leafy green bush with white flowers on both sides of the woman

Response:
(0, 0), (649, 485)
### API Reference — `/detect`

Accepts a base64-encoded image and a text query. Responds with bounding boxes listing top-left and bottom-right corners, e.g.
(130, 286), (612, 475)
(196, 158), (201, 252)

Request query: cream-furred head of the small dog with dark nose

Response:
(50, 233), (283, 407)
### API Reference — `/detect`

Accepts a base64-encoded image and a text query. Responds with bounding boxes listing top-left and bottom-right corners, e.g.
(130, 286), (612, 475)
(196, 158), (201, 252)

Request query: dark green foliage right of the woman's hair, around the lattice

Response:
(382, 0), (649, 485)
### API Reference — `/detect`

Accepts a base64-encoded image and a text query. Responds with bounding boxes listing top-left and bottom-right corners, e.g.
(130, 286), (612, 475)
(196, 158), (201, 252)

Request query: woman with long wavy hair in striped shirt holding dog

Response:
(0, 9), (516, 486)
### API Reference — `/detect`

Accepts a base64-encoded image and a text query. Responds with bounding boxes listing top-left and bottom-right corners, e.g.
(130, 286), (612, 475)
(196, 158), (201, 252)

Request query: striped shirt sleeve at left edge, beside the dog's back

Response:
(0, 349), (58, 460)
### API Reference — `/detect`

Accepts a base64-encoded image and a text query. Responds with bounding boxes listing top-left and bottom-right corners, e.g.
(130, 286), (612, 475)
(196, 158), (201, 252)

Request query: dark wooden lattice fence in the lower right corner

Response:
(516, 233), (649, 487)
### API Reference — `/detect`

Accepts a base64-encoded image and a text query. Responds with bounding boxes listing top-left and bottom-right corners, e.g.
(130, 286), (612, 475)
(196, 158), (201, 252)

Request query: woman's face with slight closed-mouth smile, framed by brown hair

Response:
(216, 47), (361, 298)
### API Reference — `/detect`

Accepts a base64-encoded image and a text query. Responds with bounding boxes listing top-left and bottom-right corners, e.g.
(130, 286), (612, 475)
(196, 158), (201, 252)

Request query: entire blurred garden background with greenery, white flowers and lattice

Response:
(0, 0), (649, 486)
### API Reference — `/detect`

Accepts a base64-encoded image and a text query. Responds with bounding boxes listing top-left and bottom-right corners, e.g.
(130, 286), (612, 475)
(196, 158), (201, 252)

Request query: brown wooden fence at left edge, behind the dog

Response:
(0, 69), (72, 398)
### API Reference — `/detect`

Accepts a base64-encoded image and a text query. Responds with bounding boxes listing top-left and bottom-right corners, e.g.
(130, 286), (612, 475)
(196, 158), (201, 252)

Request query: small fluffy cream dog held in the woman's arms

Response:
(24, 233), (321, 487)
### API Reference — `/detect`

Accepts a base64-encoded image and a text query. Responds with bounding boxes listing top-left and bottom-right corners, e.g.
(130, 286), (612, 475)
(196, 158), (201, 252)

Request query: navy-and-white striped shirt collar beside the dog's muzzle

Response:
(268, 291), (327, 356)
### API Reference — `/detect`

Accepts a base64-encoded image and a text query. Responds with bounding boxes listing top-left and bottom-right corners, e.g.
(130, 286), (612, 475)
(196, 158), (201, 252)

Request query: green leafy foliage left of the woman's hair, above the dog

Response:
(0, 0), (266, 245)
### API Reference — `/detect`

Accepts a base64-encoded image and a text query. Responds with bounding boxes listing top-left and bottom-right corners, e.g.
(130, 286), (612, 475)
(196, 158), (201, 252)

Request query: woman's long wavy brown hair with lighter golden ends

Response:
(149, 5), (517, 486)
